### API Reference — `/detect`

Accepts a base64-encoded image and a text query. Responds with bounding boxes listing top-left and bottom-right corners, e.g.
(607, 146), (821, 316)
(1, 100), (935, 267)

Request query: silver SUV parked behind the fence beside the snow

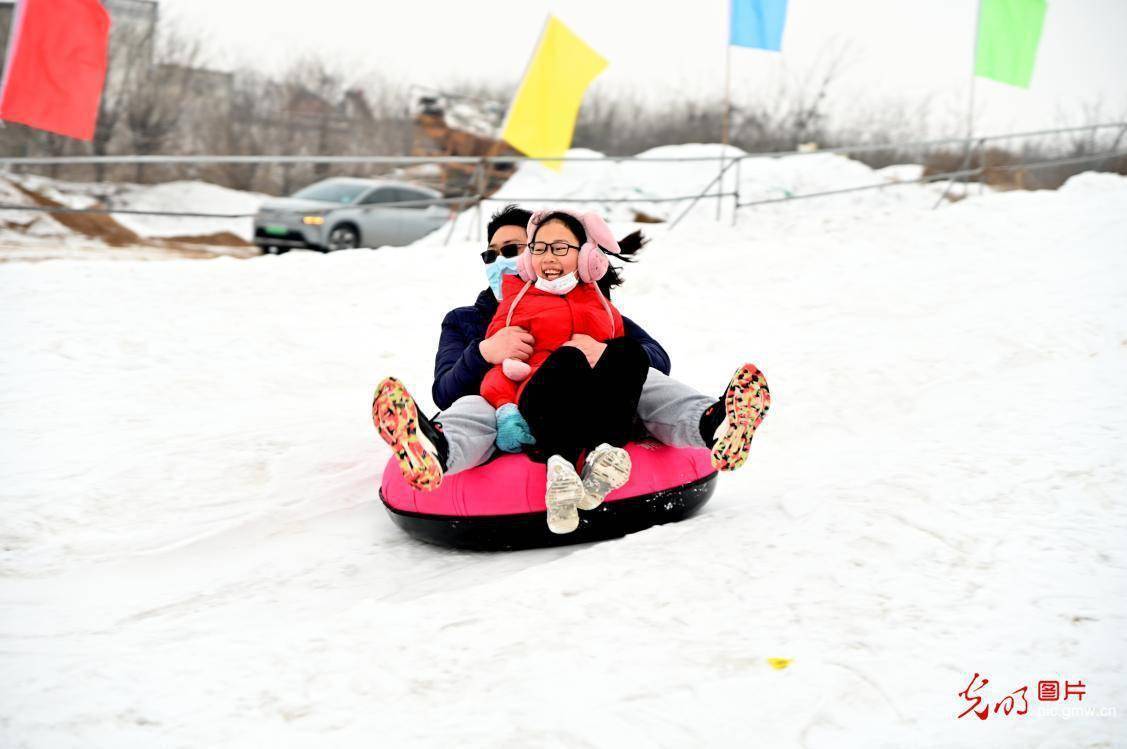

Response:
(255, 177), (450, 252)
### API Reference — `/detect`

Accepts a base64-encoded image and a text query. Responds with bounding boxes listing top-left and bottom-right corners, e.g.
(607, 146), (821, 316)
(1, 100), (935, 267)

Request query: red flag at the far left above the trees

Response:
(0, 0), (109, 141)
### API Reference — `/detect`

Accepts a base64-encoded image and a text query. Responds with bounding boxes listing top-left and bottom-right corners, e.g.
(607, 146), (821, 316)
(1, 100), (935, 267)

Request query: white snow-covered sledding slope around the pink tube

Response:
(0, 146), (1127, 748)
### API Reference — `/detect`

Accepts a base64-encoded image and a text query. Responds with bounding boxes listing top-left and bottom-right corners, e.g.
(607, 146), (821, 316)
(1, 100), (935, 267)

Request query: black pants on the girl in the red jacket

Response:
(518, 338), (649, 465)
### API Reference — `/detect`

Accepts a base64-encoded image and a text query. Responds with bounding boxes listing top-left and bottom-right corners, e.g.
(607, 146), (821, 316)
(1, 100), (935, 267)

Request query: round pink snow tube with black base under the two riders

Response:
(380, 440), (716, 550)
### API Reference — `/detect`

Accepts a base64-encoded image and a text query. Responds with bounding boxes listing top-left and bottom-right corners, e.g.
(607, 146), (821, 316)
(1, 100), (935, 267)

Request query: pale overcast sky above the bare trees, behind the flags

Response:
(160, 0), (1127, 140)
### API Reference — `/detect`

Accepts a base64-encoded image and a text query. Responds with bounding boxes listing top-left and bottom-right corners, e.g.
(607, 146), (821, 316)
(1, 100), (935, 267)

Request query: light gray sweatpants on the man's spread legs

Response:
(438, 367), (716, 475)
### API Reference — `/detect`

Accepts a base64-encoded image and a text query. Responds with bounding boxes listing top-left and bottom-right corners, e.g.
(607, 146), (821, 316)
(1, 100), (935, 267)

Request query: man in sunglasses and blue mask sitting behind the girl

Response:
(372, 205), (771, 491)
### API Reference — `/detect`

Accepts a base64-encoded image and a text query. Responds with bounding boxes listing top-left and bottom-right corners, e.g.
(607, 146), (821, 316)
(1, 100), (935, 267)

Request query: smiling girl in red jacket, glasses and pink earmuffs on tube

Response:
(481, 211), (650, 533)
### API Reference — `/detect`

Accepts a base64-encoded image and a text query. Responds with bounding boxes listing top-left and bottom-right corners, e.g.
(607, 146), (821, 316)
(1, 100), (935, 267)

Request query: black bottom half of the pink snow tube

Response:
(380, 473), (716, 551)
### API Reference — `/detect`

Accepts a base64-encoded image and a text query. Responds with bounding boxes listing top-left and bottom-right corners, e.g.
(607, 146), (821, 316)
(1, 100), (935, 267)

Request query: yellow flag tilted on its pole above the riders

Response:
(502, 17), (606, 171)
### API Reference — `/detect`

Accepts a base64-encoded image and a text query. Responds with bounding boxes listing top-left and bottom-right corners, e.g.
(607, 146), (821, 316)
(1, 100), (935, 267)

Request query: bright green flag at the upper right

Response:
(975, 0), (1045, 88)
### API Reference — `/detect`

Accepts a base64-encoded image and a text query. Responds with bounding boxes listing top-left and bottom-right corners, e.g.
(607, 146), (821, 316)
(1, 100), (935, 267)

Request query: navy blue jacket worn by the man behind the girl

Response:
(431, 288), (669, 409)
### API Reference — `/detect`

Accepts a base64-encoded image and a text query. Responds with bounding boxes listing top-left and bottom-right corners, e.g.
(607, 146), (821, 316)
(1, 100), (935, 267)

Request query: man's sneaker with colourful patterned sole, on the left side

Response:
(372, 377), (446, 491)
